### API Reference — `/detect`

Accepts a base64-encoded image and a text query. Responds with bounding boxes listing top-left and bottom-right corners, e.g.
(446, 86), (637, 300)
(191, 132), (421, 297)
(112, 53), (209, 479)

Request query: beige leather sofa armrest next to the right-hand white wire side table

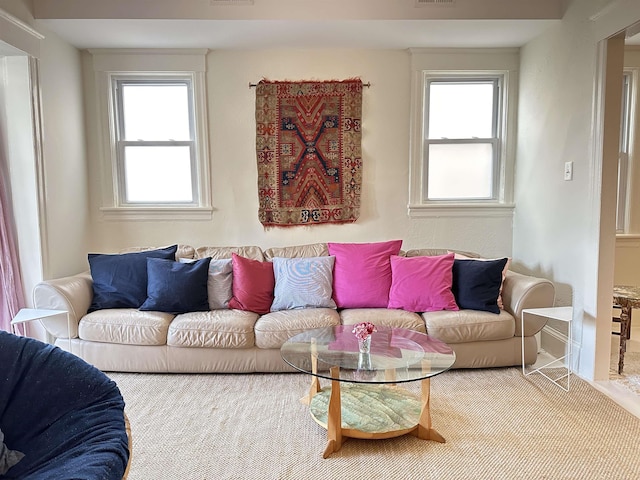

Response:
(502, 271), (556, 337)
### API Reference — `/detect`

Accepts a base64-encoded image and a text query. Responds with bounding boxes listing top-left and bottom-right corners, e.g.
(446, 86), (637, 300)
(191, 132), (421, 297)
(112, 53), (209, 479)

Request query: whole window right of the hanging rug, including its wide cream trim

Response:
(407, 48), (520, 218)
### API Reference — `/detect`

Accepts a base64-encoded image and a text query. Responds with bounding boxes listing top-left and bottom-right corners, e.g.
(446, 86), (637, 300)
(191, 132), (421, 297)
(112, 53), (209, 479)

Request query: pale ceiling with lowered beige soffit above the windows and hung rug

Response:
(5, 0), (640, 50)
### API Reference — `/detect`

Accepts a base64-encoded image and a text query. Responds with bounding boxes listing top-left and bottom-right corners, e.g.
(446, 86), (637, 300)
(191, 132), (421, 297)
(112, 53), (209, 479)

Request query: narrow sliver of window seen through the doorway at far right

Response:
(616, 72), (633, 233)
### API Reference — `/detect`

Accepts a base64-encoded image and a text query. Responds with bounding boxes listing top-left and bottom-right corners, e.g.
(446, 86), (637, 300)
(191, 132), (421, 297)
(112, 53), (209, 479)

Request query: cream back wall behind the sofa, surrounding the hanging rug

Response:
(84, 50), (511, 256)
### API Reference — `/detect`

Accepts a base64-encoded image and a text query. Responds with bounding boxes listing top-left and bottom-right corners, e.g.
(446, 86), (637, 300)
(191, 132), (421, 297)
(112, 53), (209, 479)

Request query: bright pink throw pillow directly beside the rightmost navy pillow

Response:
(389, 253), (459, 312)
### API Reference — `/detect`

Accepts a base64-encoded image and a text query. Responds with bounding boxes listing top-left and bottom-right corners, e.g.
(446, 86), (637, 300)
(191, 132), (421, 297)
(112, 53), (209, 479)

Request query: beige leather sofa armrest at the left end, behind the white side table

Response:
(33, 271), (93, 338)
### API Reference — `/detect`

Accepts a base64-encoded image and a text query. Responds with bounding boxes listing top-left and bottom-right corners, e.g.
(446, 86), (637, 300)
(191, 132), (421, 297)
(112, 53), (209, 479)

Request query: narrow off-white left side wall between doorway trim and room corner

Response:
(39, 22), (89, 278)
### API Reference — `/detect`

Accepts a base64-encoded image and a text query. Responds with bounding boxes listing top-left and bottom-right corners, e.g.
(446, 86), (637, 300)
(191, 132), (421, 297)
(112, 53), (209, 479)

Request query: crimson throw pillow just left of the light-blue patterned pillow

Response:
(229, 253), (276, 314)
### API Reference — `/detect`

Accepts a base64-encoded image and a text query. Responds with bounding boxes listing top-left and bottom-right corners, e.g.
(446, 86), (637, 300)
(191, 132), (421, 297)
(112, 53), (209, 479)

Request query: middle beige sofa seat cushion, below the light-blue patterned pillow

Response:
(255, 308), (340, 348)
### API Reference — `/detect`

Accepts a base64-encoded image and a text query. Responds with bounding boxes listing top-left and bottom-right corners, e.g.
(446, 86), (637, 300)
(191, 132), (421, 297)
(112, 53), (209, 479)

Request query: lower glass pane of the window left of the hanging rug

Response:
(124, 146), (193, 203)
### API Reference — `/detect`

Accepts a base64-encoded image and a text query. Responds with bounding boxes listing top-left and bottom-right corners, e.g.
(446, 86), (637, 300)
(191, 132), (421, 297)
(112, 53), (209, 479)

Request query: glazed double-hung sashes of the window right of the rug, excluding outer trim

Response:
(424, 77), (500, 201)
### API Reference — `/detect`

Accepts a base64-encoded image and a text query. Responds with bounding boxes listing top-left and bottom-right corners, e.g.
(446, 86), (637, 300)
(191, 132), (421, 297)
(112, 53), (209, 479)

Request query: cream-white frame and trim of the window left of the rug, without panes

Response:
(90, 49), (213, 220)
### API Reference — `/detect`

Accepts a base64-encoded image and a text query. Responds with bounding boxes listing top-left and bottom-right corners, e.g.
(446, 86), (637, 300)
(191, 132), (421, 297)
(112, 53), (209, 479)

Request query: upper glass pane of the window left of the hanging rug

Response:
(122, 84), (191, 141)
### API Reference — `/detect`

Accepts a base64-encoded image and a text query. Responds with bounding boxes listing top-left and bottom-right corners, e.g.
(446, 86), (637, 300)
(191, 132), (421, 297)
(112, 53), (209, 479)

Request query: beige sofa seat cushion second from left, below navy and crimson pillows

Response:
(167, 309), (258, 348)
